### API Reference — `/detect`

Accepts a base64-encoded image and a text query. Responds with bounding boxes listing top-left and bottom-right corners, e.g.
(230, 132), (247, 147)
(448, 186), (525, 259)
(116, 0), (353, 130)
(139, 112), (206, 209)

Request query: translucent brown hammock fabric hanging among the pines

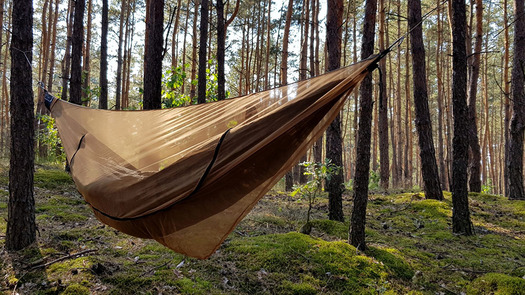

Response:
(46, 56), (380, 259)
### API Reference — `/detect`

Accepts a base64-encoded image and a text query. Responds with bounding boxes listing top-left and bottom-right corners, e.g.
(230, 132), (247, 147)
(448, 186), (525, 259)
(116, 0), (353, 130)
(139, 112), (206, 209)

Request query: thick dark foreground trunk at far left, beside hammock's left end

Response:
(5, 0), (36, 250)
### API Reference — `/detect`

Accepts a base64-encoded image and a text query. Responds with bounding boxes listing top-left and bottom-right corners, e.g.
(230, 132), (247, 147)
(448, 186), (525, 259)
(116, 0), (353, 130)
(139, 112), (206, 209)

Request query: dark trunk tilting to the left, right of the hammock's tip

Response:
(408, 0), (443, 200)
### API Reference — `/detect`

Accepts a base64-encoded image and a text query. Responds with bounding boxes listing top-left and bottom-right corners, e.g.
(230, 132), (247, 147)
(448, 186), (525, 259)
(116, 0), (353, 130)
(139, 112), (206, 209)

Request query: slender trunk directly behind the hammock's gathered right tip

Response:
(378, 0), (386, 190)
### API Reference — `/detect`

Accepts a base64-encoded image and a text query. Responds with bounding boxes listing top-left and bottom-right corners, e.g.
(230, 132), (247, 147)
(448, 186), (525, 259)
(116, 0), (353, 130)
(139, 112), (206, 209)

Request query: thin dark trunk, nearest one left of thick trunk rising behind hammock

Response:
(98, 0), (109, 109)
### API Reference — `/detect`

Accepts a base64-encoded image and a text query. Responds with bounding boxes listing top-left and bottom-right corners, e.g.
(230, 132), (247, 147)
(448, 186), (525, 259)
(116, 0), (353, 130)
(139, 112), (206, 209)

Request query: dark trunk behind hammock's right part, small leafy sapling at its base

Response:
(324, 0), (345, 221)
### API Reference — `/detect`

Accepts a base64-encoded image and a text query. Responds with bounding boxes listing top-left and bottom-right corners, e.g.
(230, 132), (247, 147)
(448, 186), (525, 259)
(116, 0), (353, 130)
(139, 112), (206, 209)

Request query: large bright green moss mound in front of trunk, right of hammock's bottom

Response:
(227, 232), (388, 293)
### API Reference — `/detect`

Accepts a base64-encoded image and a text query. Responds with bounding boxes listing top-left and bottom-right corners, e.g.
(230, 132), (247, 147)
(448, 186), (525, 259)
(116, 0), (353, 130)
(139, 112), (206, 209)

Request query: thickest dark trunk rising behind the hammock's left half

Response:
(143, 0), (164, 110)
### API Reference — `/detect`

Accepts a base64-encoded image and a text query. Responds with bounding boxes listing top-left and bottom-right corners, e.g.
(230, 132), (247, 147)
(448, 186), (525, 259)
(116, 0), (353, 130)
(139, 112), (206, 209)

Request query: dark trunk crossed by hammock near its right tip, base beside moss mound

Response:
(349, 0), (377, 250)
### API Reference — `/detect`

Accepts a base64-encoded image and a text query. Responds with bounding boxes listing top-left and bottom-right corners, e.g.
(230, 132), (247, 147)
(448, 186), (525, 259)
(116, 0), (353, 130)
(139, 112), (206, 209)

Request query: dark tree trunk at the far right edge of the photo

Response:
(507, 0), (525, 200)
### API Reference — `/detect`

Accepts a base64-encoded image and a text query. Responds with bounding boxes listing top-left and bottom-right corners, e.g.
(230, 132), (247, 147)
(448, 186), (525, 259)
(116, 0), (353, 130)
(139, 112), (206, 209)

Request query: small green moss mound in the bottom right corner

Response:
(467, 273), (525, 295)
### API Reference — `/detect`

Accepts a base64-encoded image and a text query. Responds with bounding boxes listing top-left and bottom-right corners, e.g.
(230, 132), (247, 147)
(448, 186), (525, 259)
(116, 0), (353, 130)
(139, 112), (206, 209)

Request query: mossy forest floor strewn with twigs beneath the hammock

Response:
(0, 165), (525, 294)
